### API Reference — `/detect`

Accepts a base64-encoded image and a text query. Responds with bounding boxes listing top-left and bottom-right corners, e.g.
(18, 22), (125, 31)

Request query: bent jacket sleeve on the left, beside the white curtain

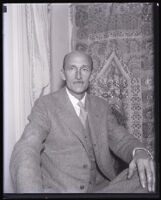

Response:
(10, 99), (50, 193)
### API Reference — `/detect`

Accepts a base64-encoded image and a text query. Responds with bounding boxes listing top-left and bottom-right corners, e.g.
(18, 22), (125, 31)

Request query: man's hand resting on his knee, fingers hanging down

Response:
(128, 150), (155, 192)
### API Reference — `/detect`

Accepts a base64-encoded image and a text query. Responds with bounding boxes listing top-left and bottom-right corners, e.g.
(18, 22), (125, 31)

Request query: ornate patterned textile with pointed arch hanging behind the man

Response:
(71, 3), (154, 152)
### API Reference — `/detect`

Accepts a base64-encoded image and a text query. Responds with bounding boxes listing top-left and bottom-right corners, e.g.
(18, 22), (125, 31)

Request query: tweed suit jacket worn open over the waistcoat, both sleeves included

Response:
(10, 88), (143, 193)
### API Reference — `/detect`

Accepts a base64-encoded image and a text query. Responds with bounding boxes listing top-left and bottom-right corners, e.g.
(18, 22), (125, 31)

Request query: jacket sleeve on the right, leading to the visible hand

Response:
(107, 106), (145, 163)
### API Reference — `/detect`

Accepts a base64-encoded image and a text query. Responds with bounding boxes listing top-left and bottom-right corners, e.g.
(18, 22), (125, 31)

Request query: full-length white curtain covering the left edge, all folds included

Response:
(3, 4), (50, 193)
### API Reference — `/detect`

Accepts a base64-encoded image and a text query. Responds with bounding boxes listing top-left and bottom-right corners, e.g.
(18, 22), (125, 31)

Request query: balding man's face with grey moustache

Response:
(64, 53), (92, 95)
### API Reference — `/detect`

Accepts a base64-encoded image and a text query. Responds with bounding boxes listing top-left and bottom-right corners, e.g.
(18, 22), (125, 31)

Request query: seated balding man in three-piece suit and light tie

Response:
(10, 51), (155, 193)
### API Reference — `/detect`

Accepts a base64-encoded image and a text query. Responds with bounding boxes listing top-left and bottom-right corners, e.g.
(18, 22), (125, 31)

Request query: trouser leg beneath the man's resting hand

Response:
(91, 169), (148, 193)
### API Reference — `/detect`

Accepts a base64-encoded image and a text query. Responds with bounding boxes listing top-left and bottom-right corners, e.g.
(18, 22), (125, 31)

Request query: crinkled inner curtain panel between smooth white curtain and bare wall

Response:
(25, 4), (50, 105)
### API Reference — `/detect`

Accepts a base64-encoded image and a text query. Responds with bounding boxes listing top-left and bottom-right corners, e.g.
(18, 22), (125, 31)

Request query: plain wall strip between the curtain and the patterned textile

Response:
(50, 4), (71, 92)
